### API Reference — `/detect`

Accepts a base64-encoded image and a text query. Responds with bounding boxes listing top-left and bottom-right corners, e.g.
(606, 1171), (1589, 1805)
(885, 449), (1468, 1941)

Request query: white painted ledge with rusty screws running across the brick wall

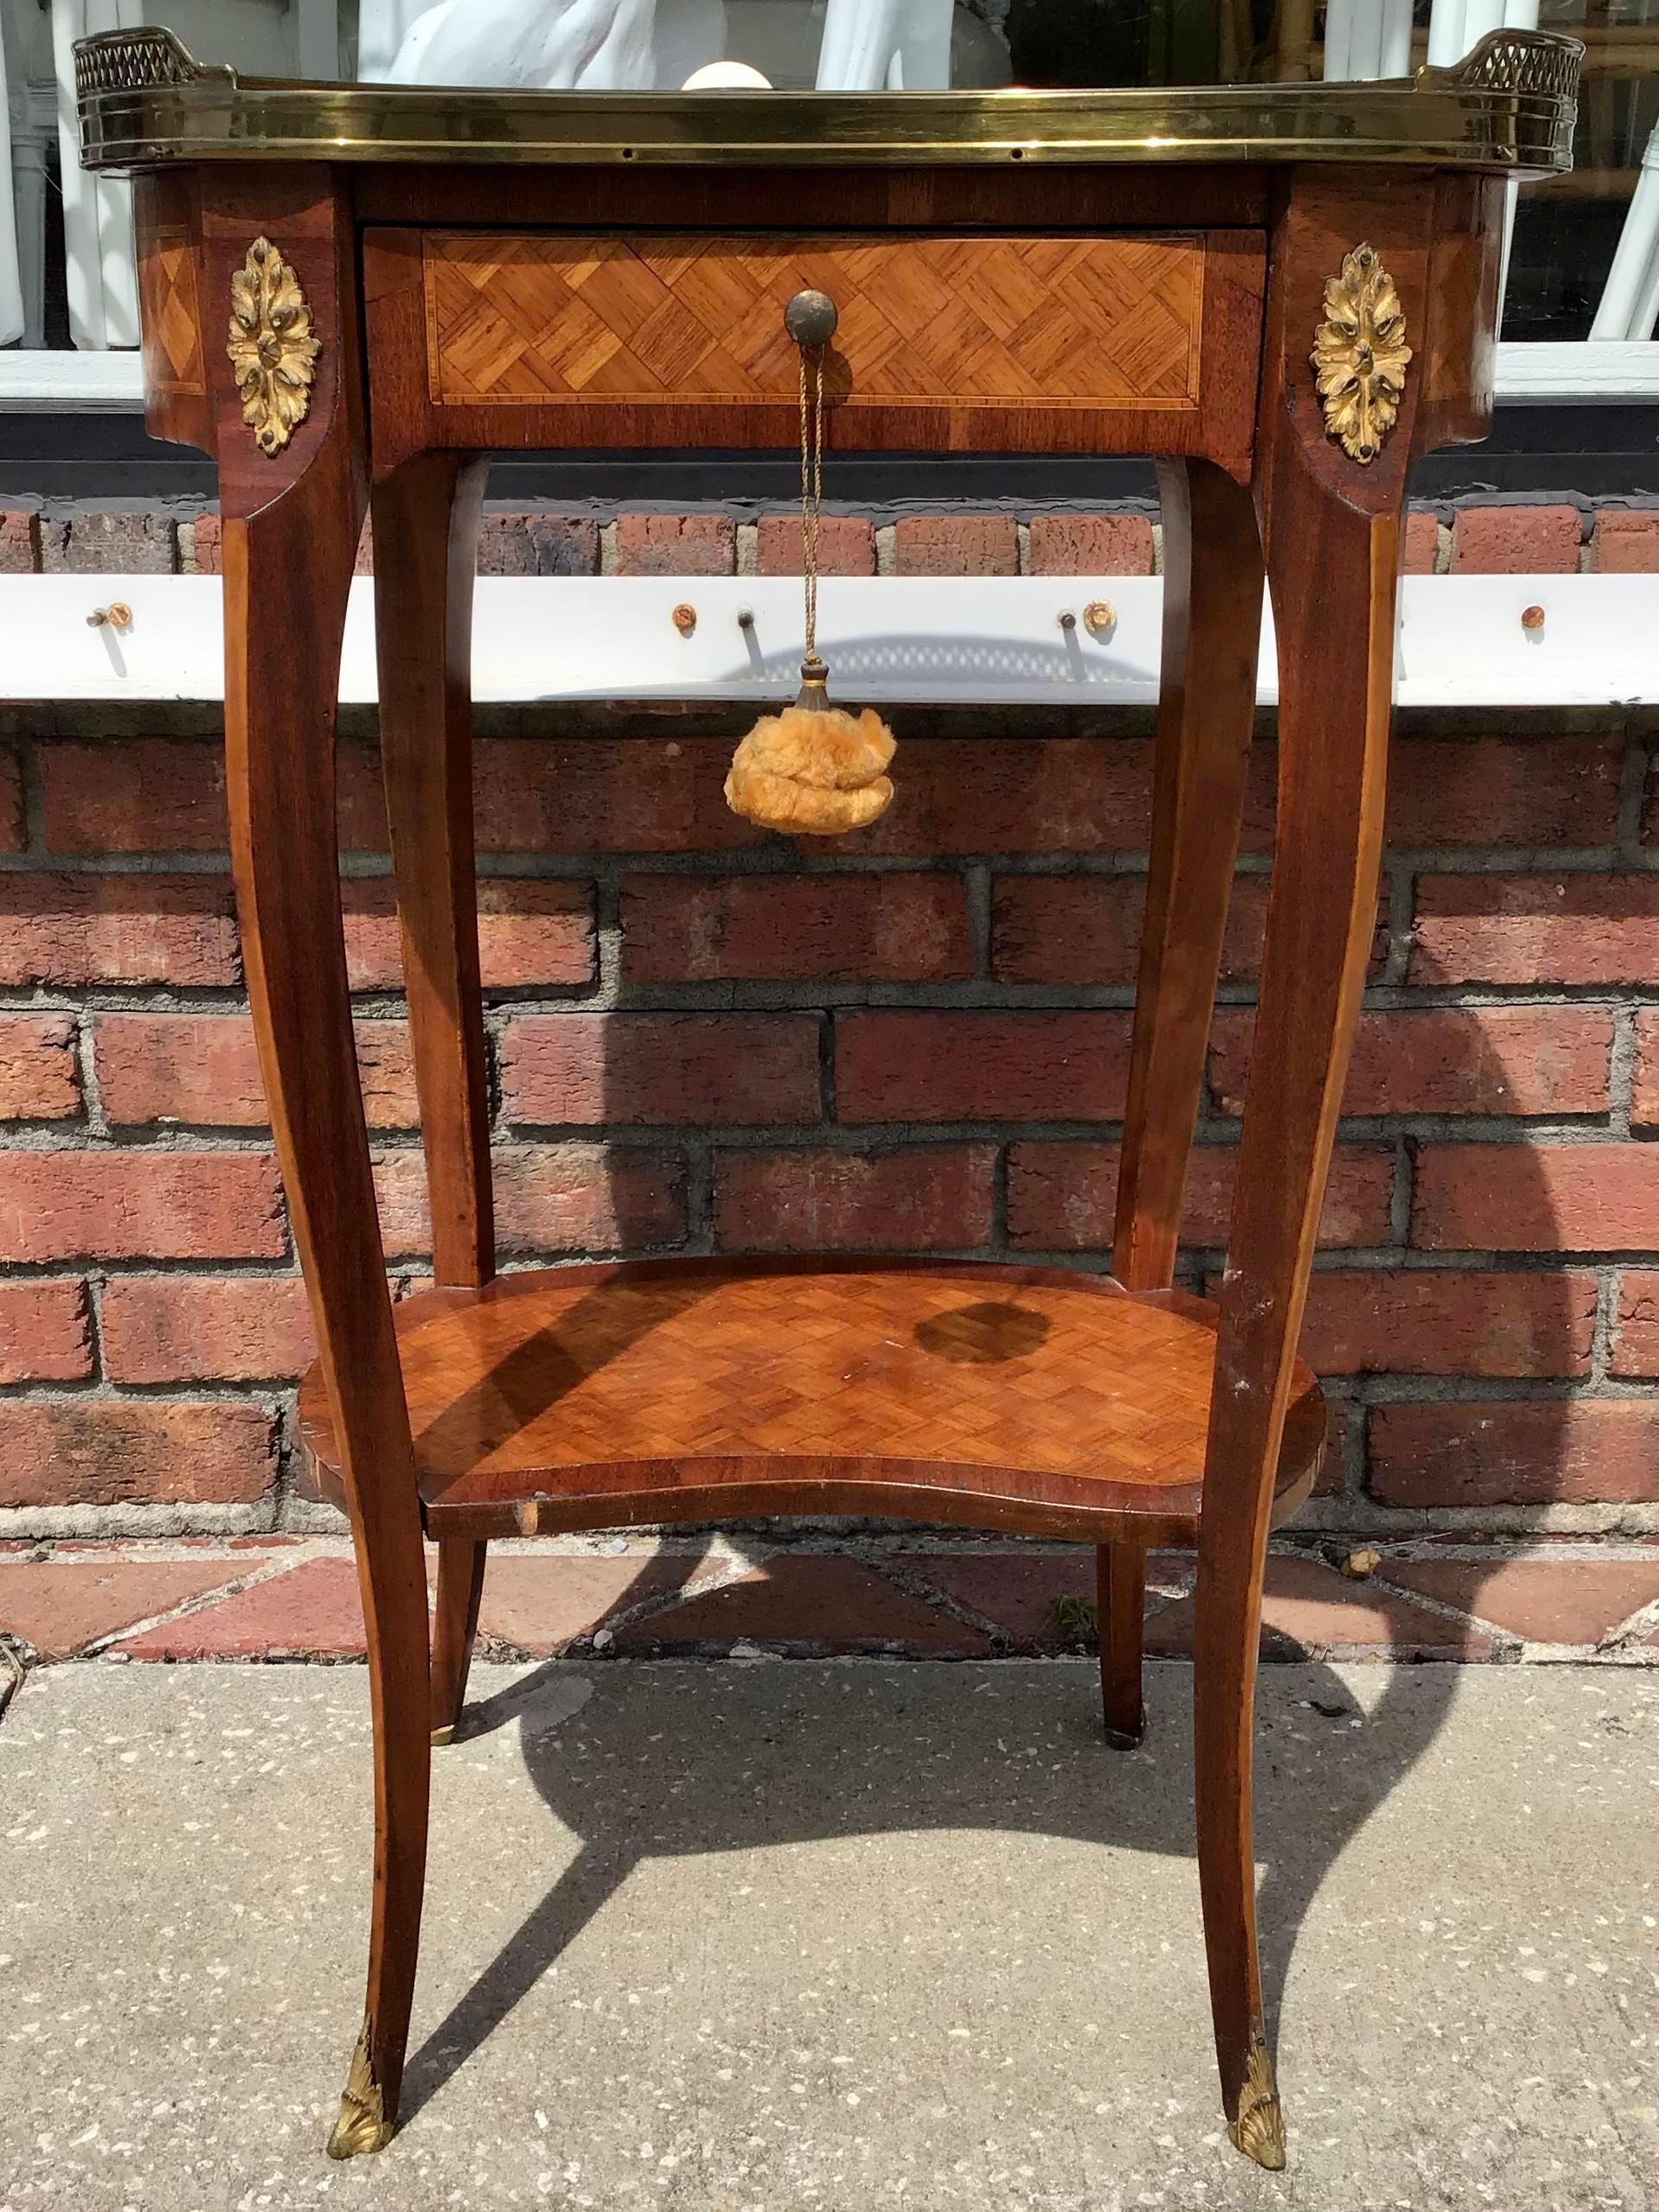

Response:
(0, 575), (1659, 706)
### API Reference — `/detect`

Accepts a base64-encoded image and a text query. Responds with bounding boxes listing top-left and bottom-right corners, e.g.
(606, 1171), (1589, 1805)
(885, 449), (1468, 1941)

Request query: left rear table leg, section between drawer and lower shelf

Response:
(372, 453), (496, 1285)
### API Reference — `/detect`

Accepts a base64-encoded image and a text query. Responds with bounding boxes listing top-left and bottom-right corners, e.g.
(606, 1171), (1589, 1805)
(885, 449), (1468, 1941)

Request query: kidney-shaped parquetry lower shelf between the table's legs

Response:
(301, 1261), (1325, 1544)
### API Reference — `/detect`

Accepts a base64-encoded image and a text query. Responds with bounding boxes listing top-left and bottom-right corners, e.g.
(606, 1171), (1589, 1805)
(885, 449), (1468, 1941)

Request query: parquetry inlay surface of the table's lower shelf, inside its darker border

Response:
(301, 1263), (1314, 1531)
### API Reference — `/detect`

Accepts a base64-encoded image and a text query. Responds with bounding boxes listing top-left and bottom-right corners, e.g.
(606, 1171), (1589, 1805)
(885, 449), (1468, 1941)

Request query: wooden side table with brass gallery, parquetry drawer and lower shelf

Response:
(78, 31), (1579, 2165)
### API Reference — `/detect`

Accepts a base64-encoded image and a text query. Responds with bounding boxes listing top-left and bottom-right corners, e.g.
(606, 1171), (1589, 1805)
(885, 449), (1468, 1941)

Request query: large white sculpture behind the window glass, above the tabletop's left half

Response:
(388, 0), (657, 91)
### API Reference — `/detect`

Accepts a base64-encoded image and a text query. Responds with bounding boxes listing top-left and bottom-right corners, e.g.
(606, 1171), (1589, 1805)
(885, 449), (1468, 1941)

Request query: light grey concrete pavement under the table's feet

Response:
(0, 1659), (1659, 2212)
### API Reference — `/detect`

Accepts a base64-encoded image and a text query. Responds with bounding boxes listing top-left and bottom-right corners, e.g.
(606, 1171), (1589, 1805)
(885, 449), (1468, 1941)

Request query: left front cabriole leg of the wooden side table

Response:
(202, 168), (429, 2144)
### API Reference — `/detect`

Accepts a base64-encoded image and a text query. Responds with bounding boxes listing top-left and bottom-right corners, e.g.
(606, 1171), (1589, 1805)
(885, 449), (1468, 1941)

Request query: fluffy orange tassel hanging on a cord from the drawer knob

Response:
(726, 292), (896, 836)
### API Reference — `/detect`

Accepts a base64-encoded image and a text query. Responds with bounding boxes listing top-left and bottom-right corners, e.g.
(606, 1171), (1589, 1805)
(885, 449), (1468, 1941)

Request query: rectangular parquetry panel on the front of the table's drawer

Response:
(425, 233), (1203, 412)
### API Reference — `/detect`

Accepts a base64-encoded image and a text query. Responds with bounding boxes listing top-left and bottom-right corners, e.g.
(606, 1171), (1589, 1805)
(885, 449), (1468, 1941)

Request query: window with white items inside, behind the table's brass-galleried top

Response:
(0, 0), (1659, 382)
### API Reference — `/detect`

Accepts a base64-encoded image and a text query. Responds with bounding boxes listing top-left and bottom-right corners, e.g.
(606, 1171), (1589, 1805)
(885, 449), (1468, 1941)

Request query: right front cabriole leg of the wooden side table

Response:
(1195, 170), (1433, 2164)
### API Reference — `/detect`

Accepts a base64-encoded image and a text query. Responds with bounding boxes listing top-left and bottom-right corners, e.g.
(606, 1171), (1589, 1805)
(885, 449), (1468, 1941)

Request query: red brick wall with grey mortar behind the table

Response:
(0, 507), (1659, 1535)
